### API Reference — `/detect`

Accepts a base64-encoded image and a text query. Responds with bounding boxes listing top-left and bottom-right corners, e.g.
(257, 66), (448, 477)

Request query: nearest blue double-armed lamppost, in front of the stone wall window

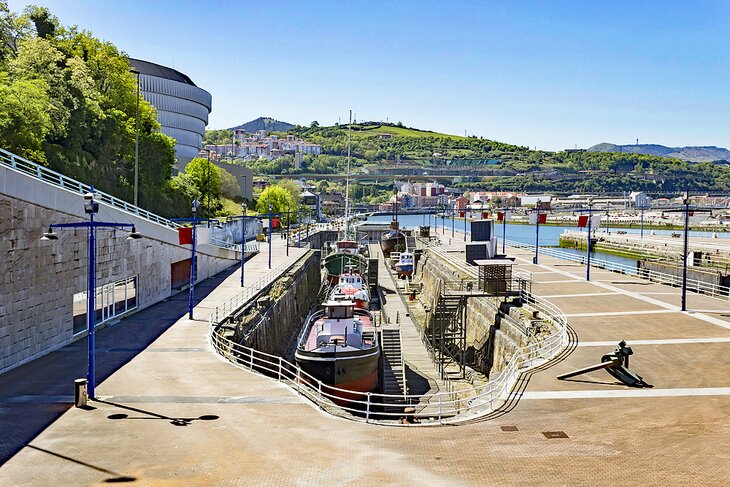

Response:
(41, 186), (142, 399)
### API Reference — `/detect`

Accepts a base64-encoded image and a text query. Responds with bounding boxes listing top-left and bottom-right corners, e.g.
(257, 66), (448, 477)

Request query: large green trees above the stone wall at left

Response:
(0, 0), (189, 215)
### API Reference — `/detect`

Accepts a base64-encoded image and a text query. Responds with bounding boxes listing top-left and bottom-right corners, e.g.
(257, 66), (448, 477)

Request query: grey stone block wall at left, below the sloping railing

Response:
(0, 168), (240, 373)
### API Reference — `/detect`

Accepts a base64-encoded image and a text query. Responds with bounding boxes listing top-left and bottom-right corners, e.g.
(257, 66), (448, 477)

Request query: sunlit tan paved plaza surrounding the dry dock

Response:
(0, 234), (730, 486)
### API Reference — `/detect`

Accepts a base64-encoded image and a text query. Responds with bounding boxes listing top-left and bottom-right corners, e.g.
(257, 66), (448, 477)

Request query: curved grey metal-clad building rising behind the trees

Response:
(129, 58), (212, 169)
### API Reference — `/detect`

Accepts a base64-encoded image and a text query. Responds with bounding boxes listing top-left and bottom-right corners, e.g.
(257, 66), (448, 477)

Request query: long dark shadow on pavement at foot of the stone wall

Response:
(0, 266), (237, 466)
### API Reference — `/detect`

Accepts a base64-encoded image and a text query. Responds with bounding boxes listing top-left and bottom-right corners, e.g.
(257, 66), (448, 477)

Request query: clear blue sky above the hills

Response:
(9, 0), (730, 150)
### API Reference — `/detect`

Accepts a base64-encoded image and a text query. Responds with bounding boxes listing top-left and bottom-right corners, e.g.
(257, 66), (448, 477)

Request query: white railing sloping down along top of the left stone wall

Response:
(0, 149), (180, 228)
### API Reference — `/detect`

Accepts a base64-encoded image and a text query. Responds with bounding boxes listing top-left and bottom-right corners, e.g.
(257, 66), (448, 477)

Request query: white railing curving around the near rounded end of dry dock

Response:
(210, 288), (568, 426)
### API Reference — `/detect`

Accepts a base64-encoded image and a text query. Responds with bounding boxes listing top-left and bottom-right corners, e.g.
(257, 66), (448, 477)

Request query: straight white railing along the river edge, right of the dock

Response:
(505, 240), (730, 299)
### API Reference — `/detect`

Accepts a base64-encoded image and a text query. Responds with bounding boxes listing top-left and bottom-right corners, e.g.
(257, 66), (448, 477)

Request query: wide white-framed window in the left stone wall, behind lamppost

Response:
(73, 276), (137, 335)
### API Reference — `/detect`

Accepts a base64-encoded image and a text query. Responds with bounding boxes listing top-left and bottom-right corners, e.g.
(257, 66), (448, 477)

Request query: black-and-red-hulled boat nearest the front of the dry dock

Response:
(294, 300), (381, 400)
